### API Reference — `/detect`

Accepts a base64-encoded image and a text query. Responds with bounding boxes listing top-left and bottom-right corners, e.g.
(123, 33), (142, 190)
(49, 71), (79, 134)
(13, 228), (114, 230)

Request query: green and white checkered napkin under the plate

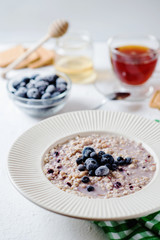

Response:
(94, 120), (160, 240)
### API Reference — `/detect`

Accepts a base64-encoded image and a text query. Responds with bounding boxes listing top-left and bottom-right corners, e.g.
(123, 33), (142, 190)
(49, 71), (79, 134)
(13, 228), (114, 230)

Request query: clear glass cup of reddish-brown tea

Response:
(108, 35), (159, 101)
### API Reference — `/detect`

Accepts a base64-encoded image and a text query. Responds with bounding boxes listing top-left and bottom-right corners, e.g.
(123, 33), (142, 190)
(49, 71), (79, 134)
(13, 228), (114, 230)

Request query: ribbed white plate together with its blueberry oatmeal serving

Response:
(8, 111), (160, 220)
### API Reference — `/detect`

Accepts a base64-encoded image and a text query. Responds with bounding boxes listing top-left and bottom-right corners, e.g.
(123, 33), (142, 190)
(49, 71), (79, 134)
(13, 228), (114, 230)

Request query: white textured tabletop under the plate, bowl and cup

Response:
(0, 43), (160, 240)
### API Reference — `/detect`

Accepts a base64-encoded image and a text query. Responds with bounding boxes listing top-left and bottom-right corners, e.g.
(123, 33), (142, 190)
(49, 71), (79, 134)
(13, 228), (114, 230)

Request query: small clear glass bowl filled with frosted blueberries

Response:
(7, 72), (71, 118)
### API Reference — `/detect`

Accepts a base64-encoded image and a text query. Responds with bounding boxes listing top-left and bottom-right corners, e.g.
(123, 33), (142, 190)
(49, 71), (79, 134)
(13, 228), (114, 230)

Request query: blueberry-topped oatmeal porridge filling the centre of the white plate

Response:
(43, 134), (156, 198)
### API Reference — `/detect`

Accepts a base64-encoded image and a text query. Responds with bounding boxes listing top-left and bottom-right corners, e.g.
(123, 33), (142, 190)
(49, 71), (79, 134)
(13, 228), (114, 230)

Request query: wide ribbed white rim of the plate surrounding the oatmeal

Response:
(8, 111), (160, 220)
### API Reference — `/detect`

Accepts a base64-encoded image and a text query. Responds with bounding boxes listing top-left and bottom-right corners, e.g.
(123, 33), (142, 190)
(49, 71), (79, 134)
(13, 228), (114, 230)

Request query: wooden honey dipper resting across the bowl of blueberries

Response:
(1, 19), (68, 78)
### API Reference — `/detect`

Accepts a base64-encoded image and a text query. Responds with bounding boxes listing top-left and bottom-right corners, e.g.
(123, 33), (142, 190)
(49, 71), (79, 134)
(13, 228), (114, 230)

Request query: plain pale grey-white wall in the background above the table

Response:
(0, 0), (160, 42)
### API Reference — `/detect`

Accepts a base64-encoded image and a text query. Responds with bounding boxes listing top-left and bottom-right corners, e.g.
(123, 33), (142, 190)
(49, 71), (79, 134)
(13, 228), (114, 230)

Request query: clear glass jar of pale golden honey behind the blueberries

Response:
(54, 31), (96, 83)
